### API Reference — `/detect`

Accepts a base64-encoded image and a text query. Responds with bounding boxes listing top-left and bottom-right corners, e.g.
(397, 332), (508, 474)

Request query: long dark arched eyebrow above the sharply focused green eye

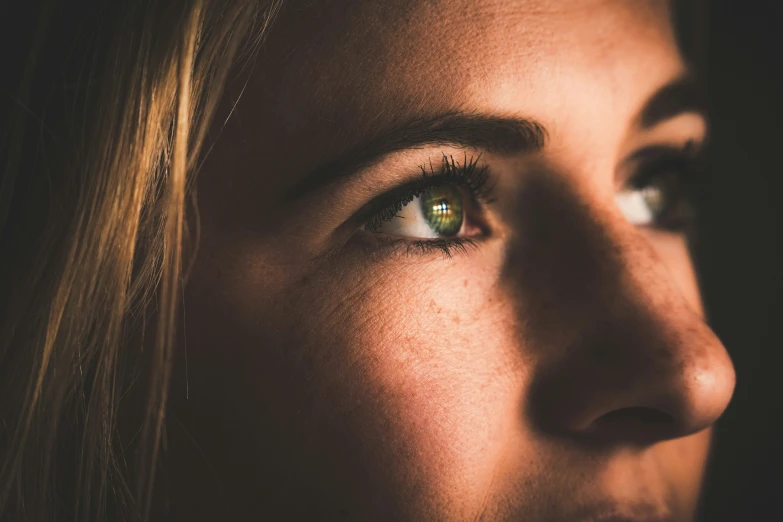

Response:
(285, 111), (547, 201)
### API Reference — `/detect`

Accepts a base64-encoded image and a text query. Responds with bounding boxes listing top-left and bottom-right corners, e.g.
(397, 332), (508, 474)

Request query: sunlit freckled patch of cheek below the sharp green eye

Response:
(318, 262), (519, 508)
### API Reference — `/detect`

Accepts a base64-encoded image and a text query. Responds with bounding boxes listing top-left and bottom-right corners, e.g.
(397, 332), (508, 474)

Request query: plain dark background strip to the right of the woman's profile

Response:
(681, 0), (783, 522)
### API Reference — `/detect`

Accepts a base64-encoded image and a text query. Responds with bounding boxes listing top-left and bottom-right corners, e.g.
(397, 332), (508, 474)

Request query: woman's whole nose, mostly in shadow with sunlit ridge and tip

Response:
(509, 177), (735, 443)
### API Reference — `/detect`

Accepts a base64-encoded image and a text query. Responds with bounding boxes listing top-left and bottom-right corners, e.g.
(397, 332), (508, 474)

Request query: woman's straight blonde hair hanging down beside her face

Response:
(0, 0), (281, 521)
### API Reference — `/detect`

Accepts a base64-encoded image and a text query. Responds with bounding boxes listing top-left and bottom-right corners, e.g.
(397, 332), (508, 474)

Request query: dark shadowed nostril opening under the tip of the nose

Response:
(587, 407), (679, 443)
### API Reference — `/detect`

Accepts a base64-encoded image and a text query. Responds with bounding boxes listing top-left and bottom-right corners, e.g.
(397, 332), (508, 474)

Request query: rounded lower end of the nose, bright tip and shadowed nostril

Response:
(530, 311), (736, 443)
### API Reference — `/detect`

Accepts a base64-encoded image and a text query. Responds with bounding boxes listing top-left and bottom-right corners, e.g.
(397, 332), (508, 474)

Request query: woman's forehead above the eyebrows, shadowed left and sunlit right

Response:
(236, 0), (683, 177)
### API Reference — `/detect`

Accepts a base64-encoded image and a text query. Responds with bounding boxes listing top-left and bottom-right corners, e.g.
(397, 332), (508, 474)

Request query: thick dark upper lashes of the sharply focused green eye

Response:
(364, 153), (494, 231)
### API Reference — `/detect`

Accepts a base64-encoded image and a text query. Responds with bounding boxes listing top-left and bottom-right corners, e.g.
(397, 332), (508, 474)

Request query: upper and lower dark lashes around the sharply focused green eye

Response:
(364, 153), (494, 258)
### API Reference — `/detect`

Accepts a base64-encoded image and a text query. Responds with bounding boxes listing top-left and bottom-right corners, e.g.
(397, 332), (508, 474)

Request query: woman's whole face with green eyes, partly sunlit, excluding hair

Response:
(175, 0), (734, 522)
